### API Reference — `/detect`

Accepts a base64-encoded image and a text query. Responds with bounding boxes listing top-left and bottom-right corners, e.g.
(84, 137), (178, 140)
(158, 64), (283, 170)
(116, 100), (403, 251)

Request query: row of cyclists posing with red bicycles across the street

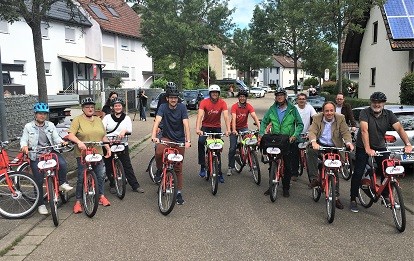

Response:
(15, 82), (412, 214)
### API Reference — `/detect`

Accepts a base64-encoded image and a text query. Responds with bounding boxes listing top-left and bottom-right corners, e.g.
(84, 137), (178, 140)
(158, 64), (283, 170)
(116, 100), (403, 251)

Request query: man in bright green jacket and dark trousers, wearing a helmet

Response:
(259, 88), (303, 197)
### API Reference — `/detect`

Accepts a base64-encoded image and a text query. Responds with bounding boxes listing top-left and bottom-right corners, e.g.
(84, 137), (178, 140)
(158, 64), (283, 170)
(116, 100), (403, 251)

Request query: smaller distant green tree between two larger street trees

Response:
(226, 28), (272, 84)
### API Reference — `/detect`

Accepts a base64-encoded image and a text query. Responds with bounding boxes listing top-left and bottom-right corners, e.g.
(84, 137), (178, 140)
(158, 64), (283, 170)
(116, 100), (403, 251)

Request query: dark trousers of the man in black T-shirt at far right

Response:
(351, 147), (389, 200)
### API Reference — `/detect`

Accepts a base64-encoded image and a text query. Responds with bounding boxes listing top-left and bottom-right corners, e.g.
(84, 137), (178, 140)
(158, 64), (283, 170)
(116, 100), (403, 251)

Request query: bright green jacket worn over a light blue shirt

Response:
(259, 102), (303, 141)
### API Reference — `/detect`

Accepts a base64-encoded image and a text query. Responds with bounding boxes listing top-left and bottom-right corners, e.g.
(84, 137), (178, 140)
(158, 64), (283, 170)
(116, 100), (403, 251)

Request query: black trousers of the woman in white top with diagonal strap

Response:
(103, 146), (139, 189)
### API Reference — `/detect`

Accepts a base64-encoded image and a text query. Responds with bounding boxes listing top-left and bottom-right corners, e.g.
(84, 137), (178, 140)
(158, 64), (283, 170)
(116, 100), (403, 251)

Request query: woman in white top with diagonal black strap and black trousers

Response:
(102, 98), (144, 194)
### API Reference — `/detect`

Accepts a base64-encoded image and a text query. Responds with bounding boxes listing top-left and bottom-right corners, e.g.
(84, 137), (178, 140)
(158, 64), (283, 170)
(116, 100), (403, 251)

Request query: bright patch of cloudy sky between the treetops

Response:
(229, 0), (261, 28)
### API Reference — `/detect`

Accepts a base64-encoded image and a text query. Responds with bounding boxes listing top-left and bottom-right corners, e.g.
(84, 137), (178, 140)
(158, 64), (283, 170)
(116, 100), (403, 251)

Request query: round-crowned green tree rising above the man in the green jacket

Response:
(251, 0), (319, 93)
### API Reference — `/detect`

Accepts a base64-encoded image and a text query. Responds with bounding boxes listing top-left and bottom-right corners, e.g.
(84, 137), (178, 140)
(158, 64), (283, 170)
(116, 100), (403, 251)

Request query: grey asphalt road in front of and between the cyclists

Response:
(3, 94), (414, 260)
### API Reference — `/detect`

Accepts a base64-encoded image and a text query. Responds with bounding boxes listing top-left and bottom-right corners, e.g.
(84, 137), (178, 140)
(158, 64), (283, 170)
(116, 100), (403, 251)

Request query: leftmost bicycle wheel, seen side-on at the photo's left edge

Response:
(0, 171), (39, 219)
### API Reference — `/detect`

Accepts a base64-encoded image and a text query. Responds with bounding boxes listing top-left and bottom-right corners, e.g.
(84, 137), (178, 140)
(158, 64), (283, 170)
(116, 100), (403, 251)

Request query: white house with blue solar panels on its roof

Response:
(342, 0), (414, 103)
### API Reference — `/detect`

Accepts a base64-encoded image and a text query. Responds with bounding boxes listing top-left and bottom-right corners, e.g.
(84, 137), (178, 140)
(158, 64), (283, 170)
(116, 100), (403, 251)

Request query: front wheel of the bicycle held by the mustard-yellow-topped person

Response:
(82, 170), (99, 218)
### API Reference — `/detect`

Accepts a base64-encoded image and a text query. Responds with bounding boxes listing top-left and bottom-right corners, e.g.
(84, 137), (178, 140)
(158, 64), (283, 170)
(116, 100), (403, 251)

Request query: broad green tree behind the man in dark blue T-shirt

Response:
(139, 0), (234, 88)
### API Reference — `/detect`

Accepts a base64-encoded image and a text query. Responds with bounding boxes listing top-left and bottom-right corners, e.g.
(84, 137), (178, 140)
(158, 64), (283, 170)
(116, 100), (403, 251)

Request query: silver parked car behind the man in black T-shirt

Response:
(352, 105), (414, 164)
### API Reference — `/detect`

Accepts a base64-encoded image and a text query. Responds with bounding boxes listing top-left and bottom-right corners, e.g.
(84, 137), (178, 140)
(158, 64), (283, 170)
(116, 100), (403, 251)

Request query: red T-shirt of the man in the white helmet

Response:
(199, 98), (227, 128)
